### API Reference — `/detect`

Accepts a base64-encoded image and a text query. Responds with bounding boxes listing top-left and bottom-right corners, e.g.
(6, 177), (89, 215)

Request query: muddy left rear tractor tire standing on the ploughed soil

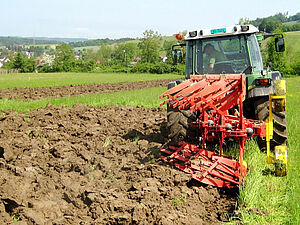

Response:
(167, 107), (197, 145)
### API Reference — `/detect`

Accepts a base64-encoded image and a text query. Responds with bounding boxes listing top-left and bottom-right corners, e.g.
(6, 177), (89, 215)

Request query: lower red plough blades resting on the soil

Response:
(161, 143), (246, 188)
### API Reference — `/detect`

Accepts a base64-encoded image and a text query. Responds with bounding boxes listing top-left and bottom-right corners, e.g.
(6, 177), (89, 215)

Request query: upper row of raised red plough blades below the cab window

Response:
(160, 74), (246, 111)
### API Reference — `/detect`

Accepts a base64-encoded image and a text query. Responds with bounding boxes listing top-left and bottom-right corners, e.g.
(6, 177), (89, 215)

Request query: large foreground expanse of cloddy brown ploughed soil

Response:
(0, 105), (236, 224)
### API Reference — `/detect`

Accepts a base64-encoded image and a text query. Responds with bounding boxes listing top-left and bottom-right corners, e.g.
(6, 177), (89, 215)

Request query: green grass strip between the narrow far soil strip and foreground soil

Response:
(0, 87), (166, 112)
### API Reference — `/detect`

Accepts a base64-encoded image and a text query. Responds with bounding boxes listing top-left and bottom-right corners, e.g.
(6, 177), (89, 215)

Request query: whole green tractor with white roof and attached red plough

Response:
(161, 25), (288, 188)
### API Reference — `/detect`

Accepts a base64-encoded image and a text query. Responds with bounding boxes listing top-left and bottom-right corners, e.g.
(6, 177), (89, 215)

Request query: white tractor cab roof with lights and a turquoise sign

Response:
(184, 24), (259, 41)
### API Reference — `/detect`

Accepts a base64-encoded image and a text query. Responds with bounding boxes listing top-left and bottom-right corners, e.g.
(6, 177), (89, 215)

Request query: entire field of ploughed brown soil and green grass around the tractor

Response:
(0, 73), (300, 224)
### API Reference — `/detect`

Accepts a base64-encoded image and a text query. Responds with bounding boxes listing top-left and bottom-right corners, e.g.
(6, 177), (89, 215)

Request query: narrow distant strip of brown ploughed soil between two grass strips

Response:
(0, 80), (172, 100)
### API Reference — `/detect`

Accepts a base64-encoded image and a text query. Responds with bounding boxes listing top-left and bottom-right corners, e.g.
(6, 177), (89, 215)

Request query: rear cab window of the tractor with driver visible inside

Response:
(186, 36), (251, 75)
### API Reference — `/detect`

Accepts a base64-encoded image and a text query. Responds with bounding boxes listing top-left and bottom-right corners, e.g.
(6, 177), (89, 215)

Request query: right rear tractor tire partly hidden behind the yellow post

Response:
(254, 96), (288, 149)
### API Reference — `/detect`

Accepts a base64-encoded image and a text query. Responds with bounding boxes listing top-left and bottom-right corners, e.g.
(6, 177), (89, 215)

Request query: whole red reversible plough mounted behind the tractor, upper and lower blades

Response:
(161, 74), (266, 188)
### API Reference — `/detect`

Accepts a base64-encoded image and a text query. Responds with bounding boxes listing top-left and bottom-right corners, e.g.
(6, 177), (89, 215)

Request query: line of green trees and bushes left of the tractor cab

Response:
(4, 30), (185, 74)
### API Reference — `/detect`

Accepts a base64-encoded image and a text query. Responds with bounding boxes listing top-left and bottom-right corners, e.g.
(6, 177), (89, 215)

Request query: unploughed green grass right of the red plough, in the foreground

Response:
(239, 77), (300, 224)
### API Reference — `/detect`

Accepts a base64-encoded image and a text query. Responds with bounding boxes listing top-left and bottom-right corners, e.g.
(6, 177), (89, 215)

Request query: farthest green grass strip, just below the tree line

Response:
(0, 73), (182, 89)
